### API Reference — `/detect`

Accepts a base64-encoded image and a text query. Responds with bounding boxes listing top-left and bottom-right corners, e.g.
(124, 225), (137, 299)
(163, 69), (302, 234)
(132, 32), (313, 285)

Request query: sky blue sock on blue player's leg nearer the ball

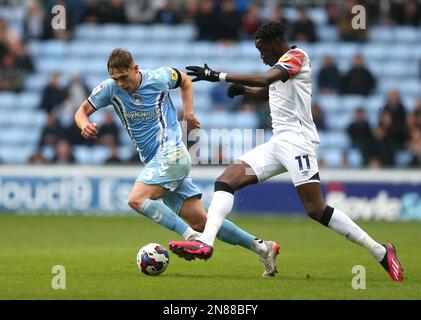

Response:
(139, 199), (189, 236)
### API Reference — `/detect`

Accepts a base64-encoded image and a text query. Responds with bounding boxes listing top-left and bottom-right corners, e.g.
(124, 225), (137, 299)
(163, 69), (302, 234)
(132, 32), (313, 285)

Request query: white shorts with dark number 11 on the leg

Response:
(240, 132), (320, 186)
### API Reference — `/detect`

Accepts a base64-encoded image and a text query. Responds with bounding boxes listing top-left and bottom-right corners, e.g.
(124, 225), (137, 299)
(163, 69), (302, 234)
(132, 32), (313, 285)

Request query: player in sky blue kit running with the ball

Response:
(75, 49), (279, 276)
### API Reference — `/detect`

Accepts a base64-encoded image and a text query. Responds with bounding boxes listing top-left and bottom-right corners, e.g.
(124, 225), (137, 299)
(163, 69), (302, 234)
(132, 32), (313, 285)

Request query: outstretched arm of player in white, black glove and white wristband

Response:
(186, 63), (289, 87)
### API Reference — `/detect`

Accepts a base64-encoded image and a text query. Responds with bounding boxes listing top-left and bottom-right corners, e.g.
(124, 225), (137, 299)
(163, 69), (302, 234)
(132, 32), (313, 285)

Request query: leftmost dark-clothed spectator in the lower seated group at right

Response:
(347, 107), (373, 164)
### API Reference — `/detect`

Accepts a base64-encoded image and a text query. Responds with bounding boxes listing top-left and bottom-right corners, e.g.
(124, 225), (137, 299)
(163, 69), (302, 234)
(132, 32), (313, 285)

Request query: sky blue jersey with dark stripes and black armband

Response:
(88, 67), (182, 163)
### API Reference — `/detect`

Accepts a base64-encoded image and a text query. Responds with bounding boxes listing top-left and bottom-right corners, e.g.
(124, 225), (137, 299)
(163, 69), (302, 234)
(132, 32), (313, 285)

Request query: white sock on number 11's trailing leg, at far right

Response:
(328, 209), (386, 261)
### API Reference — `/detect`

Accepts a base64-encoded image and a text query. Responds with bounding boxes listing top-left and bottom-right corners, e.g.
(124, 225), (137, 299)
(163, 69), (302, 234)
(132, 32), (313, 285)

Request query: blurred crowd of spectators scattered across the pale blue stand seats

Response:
(0, 0), (421, 167)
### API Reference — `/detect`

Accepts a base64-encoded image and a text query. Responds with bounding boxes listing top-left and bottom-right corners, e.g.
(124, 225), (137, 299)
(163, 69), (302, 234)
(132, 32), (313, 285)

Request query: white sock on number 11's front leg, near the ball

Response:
(197, 191), (234, 246)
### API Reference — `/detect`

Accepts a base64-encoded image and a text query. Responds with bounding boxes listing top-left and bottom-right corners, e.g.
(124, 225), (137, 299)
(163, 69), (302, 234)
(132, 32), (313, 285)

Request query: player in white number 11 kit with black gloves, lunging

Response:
(169, 22), (403, 281)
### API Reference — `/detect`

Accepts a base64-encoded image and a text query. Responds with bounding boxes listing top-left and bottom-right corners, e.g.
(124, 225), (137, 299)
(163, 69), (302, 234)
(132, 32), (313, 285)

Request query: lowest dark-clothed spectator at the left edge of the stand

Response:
(0, 52), (25, 92)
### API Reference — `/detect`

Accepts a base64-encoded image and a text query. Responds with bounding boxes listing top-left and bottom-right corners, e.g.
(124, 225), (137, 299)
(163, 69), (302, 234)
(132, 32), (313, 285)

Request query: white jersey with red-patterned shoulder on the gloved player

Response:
(269, 46), (320, 143)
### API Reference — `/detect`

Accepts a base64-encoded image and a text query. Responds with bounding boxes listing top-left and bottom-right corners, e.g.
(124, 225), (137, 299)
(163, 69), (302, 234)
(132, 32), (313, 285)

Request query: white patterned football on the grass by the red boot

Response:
(136, 243), (170, 276)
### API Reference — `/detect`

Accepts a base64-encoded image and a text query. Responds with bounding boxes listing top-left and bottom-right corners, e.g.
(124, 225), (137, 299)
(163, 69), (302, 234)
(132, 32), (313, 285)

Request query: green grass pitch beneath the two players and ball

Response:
(0, 214), (421, 300)
